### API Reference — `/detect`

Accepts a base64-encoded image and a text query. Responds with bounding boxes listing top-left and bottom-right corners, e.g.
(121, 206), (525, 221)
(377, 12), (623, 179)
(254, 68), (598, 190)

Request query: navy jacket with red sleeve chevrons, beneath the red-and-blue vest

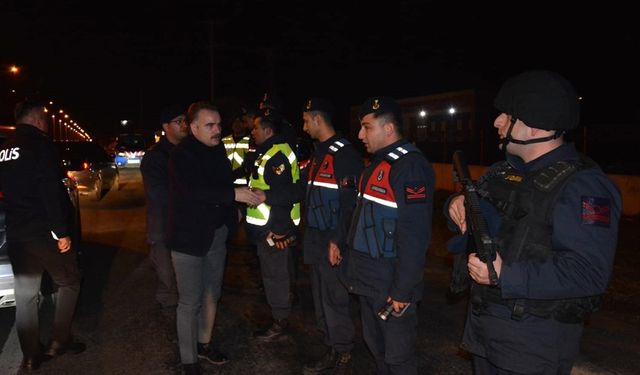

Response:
(341, 140), (435, 302)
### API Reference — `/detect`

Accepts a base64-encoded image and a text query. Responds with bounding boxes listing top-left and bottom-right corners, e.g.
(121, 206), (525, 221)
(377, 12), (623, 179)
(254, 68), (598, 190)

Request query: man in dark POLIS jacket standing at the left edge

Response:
(0, 100), (85, 370)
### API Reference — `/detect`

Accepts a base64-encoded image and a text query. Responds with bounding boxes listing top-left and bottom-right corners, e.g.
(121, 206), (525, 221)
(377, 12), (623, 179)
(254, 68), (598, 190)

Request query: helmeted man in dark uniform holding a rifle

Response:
(445, 70), (621, 375)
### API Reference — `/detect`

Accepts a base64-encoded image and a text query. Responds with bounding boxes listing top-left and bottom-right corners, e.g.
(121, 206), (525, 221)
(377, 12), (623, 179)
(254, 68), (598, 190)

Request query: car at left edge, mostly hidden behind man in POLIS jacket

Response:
(0, 125), (82, 308)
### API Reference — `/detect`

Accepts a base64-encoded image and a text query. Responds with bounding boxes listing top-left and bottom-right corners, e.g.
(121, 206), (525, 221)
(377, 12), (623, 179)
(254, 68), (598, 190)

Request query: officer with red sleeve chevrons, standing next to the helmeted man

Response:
(342, 97), (435, 375)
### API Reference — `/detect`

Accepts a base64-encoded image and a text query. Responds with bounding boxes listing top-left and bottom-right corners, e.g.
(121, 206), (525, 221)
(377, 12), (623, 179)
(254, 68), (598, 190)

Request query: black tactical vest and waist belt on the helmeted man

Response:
(471, 157), (601, 323)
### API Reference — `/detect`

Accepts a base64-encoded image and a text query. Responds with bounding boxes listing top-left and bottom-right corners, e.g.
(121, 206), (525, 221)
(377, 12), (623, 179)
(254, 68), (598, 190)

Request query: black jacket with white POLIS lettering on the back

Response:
(0, 124), (72, 241)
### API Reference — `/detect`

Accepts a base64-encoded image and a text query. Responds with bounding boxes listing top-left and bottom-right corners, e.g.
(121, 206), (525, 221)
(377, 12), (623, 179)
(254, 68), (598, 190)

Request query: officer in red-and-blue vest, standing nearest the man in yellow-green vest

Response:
(302, 98), (363, 374)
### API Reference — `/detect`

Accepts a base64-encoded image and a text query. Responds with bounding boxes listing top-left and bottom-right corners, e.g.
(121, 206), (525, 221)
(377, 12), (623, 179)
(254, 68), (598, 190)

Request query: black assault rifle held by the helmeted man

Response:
(453, 150), (498, 285)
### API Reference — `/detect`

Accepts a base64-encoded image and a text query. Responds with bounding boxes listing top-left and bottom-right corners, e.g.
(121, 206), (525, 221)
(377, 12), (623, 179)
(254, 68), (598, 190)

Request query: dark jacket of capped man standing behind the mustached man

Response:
(140, 137), (174, 244)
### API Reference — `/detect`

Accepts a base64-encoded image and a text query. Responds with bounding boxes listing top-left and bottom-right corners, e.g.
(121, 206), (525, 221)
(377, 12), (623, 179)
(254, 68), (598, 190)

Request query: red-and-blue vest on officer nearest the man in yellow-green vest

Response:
(306, 139), (350, 230)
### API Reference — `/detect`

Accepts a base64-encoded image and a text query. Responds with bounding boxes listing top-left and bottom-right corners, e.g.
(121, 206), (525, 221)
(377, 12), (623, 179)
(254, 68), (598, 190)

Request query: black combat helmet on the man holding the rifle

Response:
(493, 70), (580, 130)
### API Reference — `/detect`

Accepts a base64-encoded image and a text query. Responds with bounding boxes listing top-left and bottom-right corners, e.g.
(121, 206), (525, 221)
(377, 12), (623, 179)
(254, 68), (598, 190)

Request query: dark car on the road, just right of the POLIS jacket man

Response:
(56, 141), (120, 200)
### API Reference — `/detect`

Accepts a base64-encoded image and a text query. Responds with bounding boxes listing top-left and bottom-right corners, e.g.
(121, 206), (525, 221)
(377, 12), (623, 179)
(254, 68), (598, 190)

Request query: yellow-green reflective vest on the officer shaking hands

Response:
(247, 143), (300, 226)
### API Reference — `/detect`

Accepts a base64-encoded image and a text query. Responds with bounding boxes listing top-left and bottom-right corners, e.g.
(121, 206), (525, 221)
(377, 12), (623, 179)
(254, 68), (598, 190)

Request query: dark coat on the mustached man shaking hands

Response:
(167, 135), (238, 256)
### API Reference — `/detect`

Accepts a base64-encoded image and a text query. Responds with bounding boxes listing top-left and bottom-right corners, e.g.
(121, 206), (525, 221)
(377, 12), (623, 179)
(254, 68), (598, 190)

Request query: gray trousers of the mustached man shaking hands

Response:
(171, 226), (228, 364)
